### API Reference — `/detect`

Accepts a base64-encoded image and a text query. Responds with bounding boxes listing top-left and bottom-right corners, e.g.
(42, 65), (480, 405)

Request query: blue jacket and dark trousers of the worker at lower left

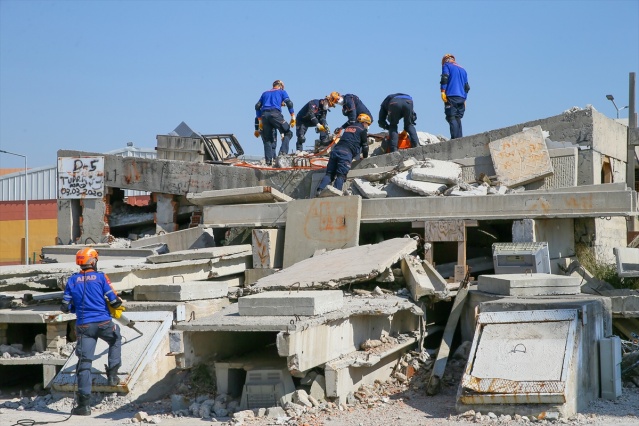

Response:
(62, 269), (122, 395)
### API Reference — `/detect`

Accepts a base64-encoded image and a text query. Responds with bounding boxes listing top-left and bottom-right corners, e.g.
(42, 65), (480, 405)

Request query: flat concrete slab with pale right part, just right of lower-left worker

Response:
(133, 276), (244, 302)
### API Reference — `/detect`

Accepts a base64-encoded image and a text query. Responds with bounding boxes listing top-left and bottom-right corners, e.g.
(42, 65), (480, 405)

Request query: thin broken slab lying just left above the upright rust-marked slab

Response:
(186, 186), (292, 206)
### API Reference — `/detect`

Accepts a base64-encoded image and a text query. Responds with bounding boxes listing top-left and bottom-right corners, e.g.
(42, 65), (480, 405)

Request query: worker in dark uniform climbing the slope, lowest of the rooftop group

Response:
(316, 114), (371, 196)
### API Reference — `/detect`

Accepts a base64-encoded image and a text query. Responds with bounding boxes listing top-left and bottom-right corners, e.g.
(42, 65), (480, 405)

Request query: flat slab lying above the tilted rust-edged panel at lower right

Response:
(477, 273), (581, 296)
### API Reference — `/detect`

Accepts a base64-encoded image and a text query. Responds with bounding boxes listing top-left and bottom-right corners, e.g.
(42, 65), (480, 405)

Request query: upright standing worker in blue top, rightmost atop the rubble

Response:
(439, 53), (470, 139)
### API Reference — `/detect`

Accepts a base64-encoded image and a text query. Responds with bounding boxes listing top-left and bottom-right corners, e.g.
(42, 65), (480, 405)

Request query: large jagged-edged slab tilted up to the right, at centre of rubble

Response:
(252, 238), (417, 290)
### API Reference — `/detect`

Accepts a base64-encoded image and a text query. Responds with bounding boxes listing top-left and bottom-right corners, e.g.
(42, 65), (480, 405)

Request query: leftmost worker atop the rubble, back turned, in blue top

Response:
(254, 80), (295, 166)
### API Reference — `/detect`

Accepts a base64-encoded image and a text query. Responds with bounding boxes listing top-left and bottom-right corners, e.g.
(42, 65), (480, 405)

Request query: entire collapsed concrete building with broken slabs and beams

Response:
(0, 108), (639, 417)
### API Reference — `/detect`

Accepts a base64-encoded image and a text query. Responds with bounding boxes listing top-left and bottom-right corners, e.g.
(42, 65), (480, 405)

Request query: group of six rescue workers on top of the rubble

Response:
(254, 53), (470, 166)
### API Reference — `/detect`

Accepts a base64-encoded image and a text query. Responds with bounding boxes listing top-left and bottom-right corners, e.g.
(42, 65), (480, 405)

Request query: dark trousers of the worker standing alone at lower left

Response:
(75, 320), (122, 395)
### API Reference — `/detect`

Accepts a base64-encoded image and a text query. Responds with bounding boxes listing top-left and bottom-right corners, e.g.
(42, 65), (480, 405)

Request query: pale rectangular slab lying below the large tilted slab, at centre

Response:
(238, 290), (344, 316)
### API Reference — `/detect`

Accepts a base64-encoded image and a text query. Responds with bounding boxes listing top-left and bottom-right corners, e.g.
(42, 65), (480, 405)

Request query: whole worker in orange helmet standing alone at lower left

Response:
(60, 248), (124, 416)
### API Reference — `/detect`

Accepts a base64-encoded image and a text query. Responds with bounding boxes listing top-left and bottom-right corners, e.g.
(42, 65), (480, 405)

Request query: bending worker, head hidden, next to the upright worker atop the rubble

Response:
(377, 93), (419, 152)
